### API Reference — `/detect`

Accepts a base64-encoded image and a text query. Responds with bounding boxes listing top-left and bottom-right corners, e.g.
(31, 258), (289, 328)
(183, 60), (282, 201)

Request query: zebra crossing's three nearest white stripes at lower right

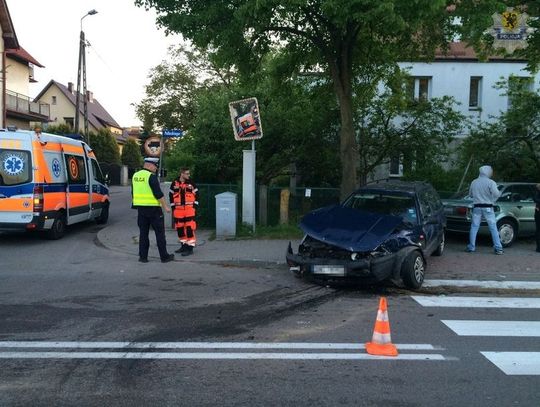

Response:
(411, 296), (540, 376)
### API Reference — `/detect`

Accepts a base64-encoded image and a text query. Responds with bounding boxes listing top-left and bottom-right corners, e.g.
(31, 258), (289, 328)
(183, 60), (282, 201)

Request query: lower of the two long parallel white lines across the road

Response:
(0, 352), (454, 361)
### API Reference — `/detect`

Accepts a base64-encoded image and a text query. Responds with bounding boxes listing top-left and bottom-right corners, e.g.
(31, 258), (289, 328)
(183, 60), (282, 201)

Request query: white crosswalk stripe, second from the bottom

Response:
(442, 320), (540, 337)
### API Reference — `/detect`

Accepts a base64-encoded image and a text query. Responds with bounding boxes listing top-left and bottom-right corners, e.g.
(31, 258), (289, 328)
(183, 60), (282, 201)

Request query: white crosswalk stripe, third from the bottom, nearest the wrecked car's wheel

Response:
(411, 295), (540, 308)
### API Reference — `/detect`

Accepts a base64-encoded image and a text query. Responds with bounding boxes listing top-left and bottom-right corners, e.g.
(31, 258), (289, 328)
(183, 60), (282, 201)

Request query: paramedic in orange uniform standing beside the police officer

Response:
(169, 168), (199, 256)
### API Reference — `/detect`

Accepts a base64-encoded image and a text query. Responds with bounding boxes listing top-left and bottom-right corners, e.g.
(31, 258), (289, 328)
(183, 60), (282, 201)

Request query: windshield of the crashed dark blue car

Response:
(343, 192), (418, 224)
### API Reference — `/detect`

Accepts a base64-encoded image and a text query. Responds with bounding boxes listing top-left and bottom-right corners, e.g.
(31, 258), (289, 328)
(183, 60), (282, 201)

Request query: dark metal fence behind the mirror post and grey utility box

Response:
(197, 184), (339, 228)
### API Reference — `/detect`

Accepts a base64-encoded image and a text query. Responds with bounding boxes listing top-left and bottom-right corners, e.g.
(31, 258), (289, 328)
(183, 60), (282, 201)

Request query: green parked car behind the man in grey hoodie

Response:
(443, 182), (536, 247)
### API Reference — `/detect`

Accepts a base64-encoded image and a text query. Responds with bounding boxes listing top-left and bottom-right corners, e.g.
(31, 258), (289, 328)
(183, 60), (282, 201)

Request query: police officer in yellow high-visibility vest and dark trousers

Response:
(131, 157), (174, 263)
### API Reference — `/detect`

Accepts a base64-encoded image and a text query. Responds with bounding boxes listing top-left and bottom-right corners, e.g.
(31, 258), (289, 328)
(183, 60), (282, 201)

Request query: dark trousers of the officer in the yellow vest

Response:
(137, 206), (169, 260)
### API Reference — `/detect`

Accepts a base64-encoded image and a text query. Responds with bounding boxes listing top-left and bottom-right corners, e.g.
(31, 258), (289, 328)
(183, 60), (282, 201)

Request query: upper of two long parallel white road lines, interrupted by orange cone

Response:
(0, 341), (438, 350)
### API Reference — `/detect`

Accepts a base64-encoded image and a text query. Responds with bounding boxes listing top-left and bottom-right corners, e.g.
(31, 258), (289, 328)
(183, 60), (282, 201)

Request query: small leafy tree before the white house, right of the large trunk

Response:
(357, 72), (465, 181)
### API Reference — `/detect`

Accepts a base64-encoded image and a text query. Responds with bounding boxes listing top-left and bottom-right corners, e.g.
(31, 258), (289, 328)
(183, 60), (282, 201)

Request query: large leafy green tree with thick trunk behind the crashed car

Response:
(135, 0), (460, 195)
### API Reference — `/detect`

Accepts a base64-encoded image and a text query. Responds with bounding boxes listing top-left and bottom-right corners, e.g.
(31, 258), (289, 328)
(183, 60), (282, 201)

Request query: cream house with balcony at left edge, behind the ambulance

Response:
(0, 0), (49, 129)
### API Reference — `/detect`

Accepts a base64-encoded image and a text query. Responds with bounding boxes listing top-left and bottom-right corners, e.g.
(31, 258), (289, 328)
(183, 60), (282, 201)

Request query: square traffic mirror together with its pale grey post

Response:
(229, 98), (263, 232)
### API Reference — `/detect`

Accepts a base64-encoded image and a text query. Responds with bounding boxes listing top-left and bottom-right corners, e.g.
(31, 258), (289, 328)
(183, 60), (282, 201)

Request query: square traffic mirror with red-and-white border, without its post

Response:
(229, 98), (262, 141)
